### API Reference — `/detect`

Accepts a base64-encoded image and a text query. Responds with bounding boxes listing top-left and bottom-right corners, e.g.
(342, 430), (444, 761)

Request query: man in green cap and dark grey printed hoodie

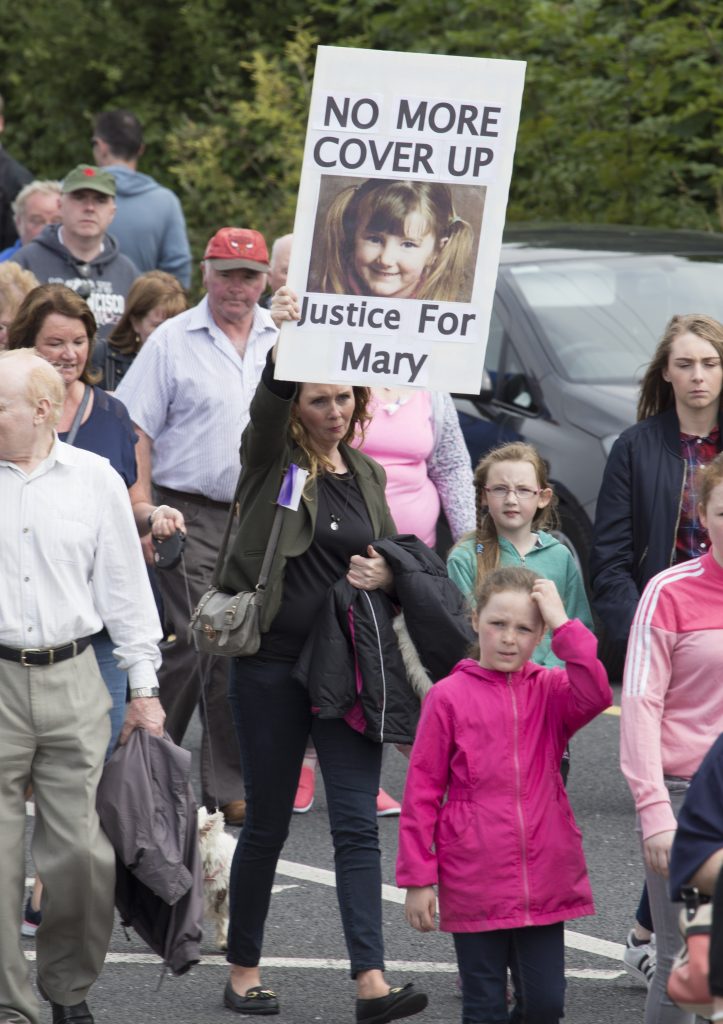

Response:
(12, 164), (138, 341)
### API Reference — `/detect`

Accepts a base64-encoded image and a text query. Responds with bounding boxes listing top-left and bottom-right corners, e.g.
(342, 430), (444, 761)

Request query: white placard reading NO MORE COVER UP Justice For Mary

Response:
(277, 46), (524, 394)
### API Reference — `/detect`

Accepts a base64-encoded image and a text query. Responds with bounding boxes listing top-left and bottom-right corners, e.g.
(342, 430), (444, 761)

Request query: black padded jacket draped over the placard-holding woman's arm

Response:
(294, 535), (474, 743)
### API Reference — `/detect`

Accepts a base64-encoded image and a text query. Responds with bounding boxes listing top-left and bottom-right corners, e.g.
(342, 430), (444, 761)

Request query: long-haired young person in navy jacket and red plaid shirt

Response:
(590, 313), (723, 1007)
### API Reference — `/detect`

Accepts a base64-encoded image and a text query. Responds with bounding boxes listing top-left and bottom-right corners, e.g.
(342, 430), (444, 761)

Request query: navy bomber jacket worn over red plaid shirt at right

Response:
(590, 409), (723, 643)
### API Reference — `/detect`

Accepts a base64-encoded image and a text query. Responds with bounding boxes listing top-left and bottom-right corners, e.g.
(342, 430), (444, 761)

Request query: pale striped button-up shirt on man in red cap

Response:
(116, 298), (278, 502)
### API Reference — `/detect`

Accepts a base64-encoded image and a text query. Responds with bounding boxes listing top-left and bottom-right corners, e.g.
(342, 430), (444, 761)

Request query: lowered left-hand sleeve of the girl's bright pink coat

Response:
(396, 680), (455, 888)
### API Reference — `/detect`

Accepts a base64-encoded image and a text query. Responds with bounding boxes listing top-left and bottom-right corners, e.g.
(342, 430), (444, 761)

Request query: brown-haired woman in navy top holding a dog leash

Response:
(8, 285), (184, 751)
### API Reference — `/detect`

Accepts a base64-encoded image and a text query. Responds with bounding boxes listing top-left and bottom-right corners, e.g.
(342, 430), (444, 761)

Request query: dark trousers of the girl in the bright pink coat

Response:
(454, 922), (565, 1024)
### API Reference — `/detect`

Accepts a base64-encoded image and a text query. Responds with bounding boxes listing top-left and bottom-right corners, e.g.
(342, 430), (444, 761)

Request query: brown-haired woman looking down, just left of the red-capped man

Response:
(101, 270), (188, 391)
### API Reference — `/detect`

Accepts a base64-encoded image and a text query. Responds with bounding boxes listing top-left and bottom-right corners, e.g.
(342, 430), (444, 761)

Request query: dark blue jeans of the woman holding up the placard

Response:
(227, 657), (384, 978)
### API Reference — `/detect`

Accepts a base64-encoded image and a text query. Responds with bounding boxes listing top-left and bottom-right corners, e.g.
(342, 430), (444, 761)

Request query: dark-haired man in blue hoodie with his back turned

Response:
(93, 111), (190, 288)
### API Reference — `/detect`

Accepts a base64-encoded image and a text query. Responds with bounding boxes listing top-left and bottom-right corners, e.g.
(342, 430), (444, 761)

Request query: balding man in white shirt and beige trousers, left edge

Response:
(0, 349), (164, 1024)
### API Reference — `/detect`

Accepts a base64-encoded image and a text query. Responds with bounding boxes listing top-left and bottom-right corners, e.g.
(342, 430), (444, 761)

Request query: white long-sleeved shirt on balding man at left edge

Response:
(0, 437), (162, 687)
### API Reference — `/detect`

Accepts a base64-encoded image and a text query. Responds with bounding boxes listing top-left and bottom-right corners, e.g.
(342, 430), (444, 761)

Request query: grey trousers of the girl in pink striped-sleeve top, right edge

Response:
(645, 782), (697, 1024)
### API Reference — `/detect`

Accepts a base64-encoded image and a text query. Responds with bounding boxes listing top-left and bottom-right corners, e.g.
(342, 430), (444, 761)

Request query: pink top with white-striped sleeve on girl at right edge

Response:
(621, 554), (723, 839)
